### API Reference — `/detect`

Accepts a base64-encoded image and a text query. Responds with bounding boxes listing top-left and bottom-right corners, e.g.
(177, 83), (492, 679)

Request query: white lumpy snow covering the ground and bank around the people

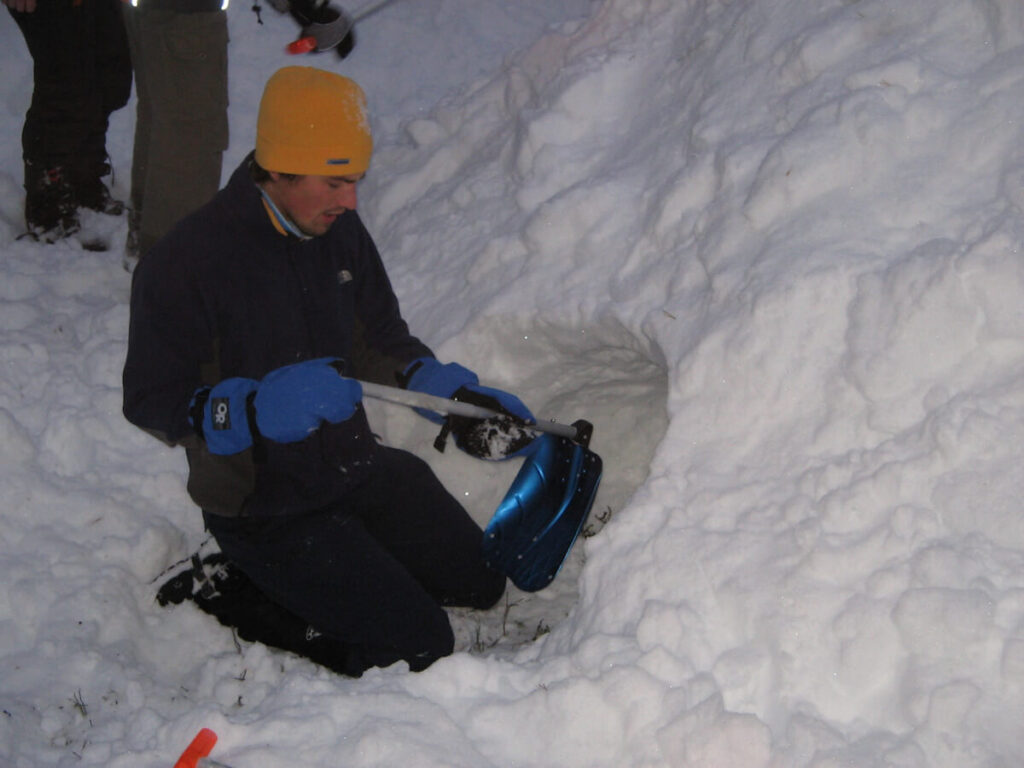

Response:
(0, 0), (1024, 768)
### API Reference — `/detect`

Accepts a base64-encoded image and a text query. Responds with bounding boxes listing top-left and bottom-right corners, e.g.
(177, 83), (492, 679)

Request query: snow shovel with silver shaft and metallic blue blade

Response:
(360, 382), (601, 592)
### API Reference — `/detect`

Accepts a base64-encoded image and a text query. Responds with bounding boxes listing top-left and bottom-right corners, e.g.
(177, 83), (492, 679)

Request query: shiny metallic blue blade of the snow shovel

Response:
(483, 434), (602, 592)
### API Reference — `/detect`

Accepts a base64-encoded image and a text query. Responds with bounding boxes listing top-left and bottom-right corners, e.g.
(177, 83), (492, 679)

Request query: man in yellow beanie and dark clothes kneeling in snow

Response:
(124, 67), (532, 675)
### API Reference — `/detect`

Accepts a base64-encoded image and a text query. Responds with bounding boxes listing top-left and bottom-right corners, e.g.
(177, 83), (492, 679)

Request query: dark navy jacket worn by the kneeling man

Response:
(124, 158), (432, 515)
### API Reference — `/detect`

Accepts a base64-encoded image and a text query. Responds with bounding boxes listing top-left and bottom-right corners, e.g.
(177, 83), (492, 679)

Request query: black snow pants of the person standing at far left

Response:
(10, 0), (132, 188)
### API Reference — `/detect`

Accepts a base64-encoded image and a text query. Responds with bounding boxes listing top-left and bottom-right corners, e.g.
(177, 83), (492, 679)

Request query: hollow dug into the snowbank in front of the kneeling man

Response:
(367, 319), (668, 654)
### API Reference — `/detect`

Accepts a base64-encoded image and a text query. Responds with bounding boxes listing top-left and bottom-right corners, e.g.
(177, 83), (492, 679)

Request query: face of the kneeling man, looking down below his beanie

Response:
(263, 171), (364, 237)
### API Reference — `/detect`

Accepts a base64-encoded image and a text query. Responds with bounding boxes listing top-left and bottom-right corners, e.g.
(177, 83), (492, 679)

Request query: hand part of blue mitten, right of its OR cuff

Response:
(253, 357), (362, 442)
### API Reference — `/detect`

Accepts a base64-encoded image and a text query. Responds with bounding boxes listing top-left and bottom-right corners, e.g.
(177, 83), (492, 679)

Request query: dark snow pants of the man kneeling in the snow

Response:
(205, 446), (505, 676)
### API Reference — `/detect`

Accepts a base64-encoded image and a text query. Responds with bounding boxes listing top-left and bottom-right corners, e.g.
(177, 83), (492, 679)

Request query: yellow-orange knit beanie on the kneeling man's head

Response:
(256, 67), (374, 176)
